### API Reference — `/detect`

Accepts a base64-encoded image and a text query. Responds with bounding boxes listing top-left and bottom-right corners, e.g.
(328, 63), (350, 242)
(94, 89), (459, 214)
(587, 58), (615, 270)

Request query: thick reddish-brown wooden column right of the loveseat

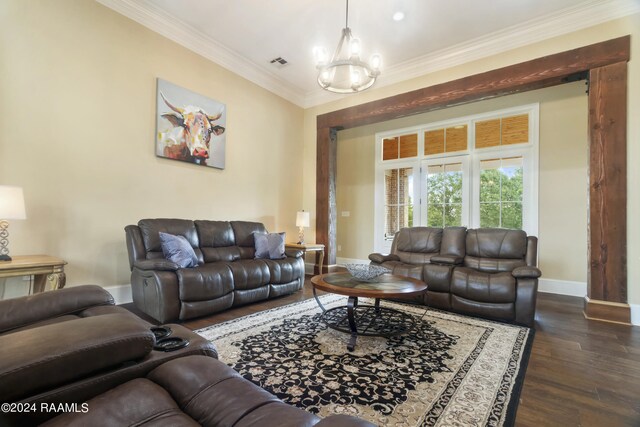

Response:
(584, 62), (631, 323)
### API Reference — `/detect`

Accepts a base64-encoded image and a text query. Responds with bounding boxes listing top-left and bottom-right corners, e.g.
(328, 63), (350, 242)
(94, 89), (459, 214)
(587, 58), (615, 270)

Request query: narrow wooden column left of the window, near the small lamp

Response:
(316, 127), (338, 274)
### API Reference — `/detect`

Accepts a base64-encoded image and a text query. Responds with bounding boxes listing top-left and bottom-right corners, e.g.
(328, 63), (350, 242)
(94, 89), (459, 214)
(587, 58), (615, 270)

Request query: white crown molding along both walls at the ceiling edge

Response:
(96, 0), (640, 108)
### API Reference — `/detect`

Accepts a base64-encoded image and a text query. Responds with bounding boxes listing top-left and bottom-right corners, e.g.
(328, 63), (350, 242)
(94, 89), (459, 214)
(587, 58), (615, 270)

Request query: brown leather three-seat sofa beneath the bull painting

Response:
(125, 219), (304, 322)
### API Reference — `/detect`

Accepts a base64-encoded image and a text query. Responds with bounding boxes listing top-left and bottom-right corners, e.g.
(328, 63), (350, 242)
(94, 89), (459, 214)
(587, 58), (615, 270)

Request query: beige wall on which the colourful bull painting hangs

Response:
(0, 0), (304, 294)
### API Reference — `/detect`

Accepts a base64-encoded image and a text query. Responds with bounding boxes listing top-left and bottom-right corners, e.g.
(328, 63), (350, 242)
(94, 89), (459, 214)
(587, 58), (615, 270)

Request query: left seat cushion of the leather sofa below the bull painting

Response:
(176, 262), (234, 301)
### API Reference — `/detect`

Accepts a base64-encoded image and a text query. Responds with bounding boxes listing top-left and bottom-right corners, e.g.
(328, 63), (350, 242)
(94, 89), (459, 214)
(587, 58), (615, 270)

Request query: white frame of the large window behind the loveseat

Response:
(373, 103), (540, 253)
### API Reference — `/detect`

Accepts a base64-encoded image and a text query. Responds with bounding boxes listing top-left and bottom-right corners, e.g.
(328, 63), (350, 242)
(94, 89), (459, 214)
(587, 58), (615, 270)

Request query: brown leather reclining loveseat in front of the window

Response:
(369, 227), (541, 326)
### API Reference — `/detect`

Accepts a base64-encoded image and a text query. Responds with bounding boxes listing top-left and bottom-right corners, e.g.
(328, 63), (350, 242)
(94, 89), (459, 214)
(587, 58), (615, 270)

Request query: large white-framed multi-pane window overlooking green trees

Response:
(374, 104), (539, 252)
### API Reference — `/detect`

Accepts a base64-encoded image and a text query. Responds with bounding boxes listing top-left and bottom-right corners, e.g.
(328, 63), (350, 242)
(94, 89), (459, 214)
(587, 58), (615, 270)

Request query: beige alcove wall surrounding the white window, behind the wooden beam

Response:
(336, 82), (588, 282)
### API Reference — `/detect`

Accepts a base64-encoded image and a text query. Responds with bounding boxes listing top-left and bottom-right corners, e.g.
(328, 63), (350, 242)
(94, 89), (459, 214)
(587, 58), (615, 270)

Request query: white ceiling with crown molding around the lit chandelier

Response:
(97, 0), (640, 108)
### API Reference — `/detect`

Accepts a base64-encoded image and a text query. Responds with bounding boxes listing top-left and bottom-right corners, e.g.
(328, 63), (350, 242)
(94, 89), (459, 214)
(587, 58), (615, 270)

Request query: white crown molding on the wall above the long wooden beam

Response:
(304, 0), (640, 108)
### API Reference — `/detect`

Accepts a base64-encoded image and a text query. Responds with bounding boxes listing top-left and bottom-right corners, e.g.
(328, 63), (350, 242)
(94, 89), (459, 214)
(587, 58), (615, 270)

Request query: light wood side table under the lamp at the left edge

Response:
(0, 255), (67, 296)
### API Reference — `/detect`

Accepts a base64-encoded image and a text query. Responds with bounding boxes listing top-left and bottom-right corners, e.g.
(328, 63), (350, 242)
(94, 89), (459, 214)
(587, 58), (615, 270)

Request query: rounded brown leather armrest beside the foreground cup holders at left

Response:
(0, 314), (155, 402)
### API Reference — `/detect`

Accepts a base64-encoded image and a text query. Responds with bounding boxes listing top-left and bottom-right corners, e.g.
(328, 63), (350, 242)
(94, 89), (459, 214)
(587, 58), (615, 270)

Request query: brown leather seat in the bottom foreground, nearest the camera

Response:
(43, 356), (373, 427)
